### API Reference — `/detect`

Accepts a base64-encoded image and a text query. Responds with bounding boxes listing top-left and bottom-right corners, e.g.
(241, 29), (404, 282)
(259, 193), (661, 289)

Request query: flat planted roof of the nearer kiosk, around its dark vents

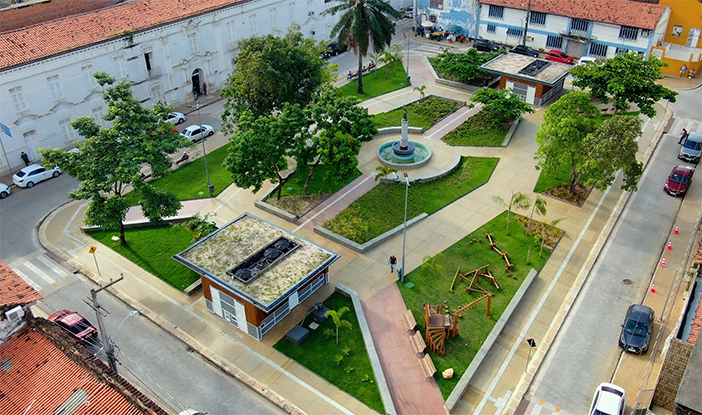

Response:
(173, 213), (339, 308)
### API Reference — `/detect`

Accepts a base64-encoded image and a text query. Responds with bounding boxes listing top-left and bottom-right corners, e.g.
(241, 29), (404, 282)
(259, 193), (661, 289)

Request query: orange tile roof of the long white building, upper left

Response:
(0, 0), (247, 69)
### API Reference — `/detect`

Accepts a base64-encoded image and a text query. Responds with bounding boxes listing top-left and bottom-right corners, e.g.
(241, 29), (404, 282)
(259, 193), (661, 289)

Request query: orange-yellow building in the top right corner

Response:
(651, 0), (702, 76)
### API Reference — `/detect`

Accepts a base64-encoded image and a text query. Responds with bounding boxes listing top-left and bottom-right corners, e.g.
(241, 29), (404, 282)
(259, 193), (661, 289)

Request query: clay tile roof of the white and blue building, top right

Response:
(478, 0), (666, 29)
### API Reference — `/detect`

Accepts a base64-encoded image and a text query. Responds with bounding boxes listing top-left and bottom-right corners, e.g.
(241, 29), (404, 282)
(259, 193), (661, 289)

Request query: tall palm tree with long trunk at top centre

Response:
(322, 0), (402, 94)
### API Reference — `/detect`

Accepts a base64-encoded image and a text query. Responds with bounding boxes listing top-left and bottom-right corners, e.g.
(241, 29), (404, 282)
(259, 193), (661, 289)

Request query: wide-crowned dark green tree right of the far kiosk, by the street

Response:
(570, 53), (678, 117)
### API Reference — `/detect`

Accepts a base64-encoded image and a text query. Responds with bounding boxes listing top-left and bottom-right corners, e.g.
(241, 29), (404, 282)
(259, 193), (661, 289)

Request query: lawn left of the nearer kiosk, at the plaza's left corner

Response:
(88, 225), (200, 291)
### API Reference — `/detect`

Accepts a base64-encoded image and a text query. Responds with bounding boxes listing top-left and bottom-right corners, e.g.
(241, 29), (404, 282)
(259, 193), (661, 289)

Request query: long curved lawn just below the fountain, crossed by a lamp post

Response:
(324, 157), (499, 244)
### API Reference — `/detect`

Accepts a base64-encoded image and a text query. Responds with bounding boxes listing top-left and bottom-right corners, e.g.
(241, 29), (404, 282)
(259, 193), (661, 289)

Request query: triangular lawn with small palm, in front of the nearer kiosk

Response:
(273, 293), (385, 414)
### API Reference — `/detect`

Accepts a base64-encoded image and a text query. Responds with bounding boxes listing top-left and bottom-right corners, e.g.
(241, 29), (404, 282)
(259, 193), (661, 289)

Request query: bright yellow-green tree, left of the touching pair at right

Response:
(536, 90), (600, 193)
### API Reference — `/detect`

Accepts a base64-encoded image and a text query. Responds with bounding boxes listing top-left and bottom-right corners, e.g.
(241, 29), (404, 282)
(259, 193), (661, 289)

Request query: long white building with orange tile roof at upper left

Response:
(0, 0), (346, 174)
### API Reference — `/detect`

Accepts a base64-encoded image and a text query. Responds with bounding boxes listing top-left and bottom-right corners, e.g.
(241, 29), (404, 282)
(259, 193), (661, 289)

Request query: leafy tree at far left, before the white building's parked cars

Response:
(40, 72), (190, 245)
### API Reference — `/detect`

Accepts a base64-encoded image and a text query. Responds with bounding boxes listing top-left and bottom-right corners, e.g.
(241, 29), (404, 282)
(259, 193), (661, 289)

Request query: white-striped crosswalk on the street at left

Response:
(9, 253), (73, 295)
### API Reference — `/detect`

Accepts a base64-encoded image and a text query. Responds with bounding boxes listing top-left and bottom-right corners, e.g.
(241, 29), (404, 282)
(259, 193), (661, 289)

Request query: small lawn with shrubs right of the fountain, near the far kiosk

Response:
(442, 111), (509, 147)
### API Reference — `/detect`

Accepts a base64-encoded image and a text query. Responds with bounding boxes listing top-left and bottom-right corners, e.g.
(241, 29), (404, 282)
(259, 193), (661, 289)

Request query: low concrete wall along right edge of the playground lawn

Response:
(446, 268), (539, 412)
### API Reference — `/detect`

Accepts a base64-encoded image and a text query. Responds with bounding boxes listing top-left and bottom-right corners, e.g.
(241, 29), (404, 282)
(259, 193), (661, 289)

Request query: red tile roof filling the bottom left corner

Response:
(0, 327), (141, 415)
